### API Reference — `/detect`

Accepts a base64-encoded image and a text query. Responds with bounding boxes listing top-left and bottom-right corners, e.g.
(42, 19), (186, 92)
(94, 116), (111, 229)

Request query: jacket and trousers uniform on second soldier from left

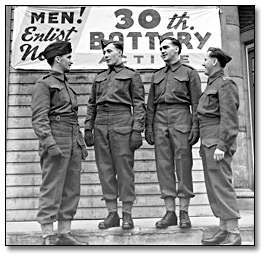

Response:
(85, 64), (145, 202)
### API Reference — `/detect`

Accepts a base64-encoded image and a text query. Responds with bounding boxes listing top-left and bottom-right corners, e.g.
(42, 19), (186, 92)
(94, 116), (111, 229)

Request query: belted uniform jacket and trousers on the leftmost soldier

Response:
(32, 71), (86, 224)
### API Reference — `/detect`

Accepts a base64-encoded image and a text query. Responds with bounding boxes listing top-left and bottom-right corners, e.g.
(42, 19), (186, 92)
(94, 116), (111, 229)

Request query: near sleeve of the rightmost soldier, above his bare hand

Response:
(217, 80), (239, 152)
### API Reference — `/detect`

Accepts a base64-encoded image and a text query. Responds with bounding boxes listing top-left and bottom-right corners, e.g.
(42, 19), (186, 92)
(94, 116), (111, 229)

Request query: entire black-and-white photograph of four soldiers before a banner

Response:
(3, 2), (260, 254)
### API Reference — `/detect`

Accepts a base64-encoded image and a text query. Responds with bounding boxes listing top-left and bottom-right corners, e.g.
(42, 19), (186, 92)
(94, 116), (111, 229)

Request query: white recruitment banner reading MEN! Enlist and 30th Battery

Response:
(11, 6), (221, 70)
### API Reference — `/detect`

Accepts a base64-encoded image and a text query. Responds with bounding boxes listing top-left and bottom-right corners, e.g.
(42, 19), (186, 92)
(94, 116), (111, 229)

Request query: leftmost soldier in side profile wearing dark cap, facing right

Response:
(31, 41), (87, 245)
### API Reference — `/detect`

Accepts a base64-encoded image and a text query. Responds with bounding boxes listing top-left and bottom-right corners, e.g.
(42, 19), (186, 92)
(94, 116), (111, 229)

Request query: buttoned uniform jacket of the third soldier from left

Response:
(146, 60), (201, 132)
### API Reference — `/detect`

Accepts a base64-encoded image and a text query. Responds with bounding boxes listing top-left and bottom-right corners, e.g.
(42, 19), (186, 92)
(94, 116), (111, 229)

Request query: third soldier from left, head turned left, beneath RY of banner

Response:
(145, 37), (201, 228)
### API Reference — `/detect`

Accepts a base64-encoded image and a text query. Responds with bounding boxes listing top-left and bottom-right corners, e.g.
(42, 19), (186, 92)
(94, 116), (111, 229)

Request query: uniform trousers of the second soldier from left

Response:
(94, 107), (135, 202)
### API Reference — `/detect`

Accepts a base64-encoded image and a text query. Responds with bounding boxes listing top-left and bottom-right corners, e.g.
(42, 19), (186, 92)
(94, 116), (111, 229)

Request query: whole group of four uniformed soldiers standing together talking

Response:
(32, 37), (241, 245)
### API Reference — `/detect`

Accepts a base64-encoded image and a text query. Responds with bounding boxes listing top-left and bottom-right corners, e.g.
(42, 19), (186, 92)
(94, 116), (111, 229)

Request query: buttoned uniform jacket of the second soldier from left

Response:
(85, 64), (145, 131)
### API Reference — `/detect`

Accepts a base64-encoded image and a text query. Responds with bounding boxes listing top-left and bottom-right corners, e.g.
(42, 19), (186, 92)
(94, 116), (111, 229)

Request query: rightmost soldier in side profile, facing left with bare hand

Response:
(198, 47), (241, 245)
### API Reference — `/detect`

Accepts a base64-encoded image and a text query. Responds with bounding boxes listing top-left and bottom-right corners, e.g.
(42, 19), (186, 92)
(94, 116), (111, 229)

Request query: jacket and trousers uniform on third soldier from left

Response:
(146, 60), (201, 207)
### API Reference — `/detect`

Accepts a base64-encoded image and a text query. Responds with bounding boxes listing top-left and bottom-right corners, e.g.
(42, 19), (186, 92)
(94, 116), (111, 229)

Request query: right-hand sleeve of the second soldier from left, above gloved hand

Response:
(131, 71), (146, 131)
